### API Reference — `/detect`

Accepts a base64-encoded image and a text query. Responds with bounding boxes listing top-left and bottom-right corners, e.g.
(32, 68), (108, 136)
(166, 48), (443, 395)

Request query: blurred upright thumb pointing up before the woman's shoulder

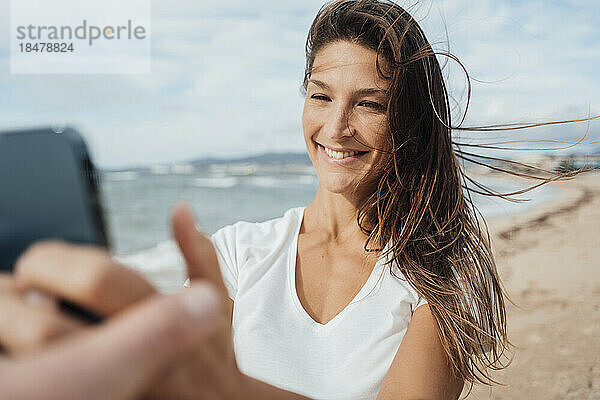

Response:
(171, 203), (226, 291)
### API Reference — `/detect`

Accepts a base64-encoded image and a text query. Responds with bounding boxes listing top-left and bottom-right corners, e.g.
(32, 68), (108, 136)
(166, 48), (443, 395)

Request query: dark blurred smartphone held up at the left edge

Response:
(0, 128), (109, 322)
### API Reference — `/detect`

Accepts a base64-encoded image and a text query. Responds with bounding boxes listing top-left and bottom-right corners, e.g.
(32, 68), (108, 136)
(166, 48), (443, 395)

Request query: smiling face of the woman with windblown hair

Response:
(302, 41), (389, 194)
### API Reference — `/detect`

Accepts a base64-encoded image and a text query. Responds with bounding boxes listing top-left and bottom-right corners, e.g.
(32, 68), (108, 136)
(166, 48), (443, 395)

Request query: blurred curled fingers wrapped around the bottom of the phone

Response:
(0, 241), (156, 355)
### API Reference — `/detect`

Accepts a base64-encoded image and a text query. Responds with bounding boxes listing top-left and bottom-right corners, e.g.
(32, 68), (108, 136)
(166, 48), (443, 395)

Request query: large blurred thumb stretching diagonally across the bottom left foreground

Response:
(9, 283), (225, 400)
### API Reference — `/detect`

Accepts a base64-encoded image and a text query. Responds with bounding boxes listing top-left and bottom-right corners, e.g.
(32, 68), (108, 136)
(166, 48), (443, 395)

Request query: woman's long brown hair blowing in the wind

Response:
(303, 0), (589, 390)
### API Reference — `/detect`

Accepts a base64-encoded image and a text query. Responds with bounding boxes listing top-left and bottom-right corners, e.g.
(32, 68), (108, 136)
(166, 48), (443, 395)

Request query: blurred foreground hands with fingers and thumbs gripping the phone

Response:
(0, 204), (245, 400)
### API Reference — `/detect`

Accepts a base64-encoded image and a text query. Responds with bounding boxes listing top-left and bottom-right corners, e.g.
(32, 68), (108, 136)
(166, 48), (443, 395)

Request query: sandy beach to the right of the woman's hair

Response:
(463, 173), (600, 400)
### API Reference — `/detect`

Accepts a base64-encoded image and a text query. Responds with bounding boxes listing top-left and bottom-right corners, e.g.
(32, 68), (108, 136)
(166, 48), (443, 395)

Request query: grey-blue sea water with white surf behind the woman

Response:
(101, 168), (555, 290)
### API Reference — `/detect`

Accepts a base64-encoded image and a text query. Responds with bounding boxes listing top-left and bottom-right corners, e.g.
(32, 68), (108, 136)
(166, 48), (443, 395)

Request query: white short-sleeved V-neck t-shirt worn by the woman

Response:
(212, 207), (426, 400)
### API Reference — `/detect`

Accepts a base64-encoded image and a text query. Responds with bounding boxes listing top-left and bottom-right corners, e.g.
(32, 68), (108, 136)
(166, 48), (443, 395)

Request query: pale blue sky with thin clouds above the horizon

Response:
(0, 0), (600, 168)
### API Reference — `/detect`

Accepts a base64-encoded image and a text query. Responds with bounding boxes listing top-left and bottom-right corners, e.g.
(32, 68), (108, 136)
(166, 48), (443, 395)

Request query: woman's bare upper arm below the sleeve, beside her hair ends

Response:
(377, 305), (463, 400)
